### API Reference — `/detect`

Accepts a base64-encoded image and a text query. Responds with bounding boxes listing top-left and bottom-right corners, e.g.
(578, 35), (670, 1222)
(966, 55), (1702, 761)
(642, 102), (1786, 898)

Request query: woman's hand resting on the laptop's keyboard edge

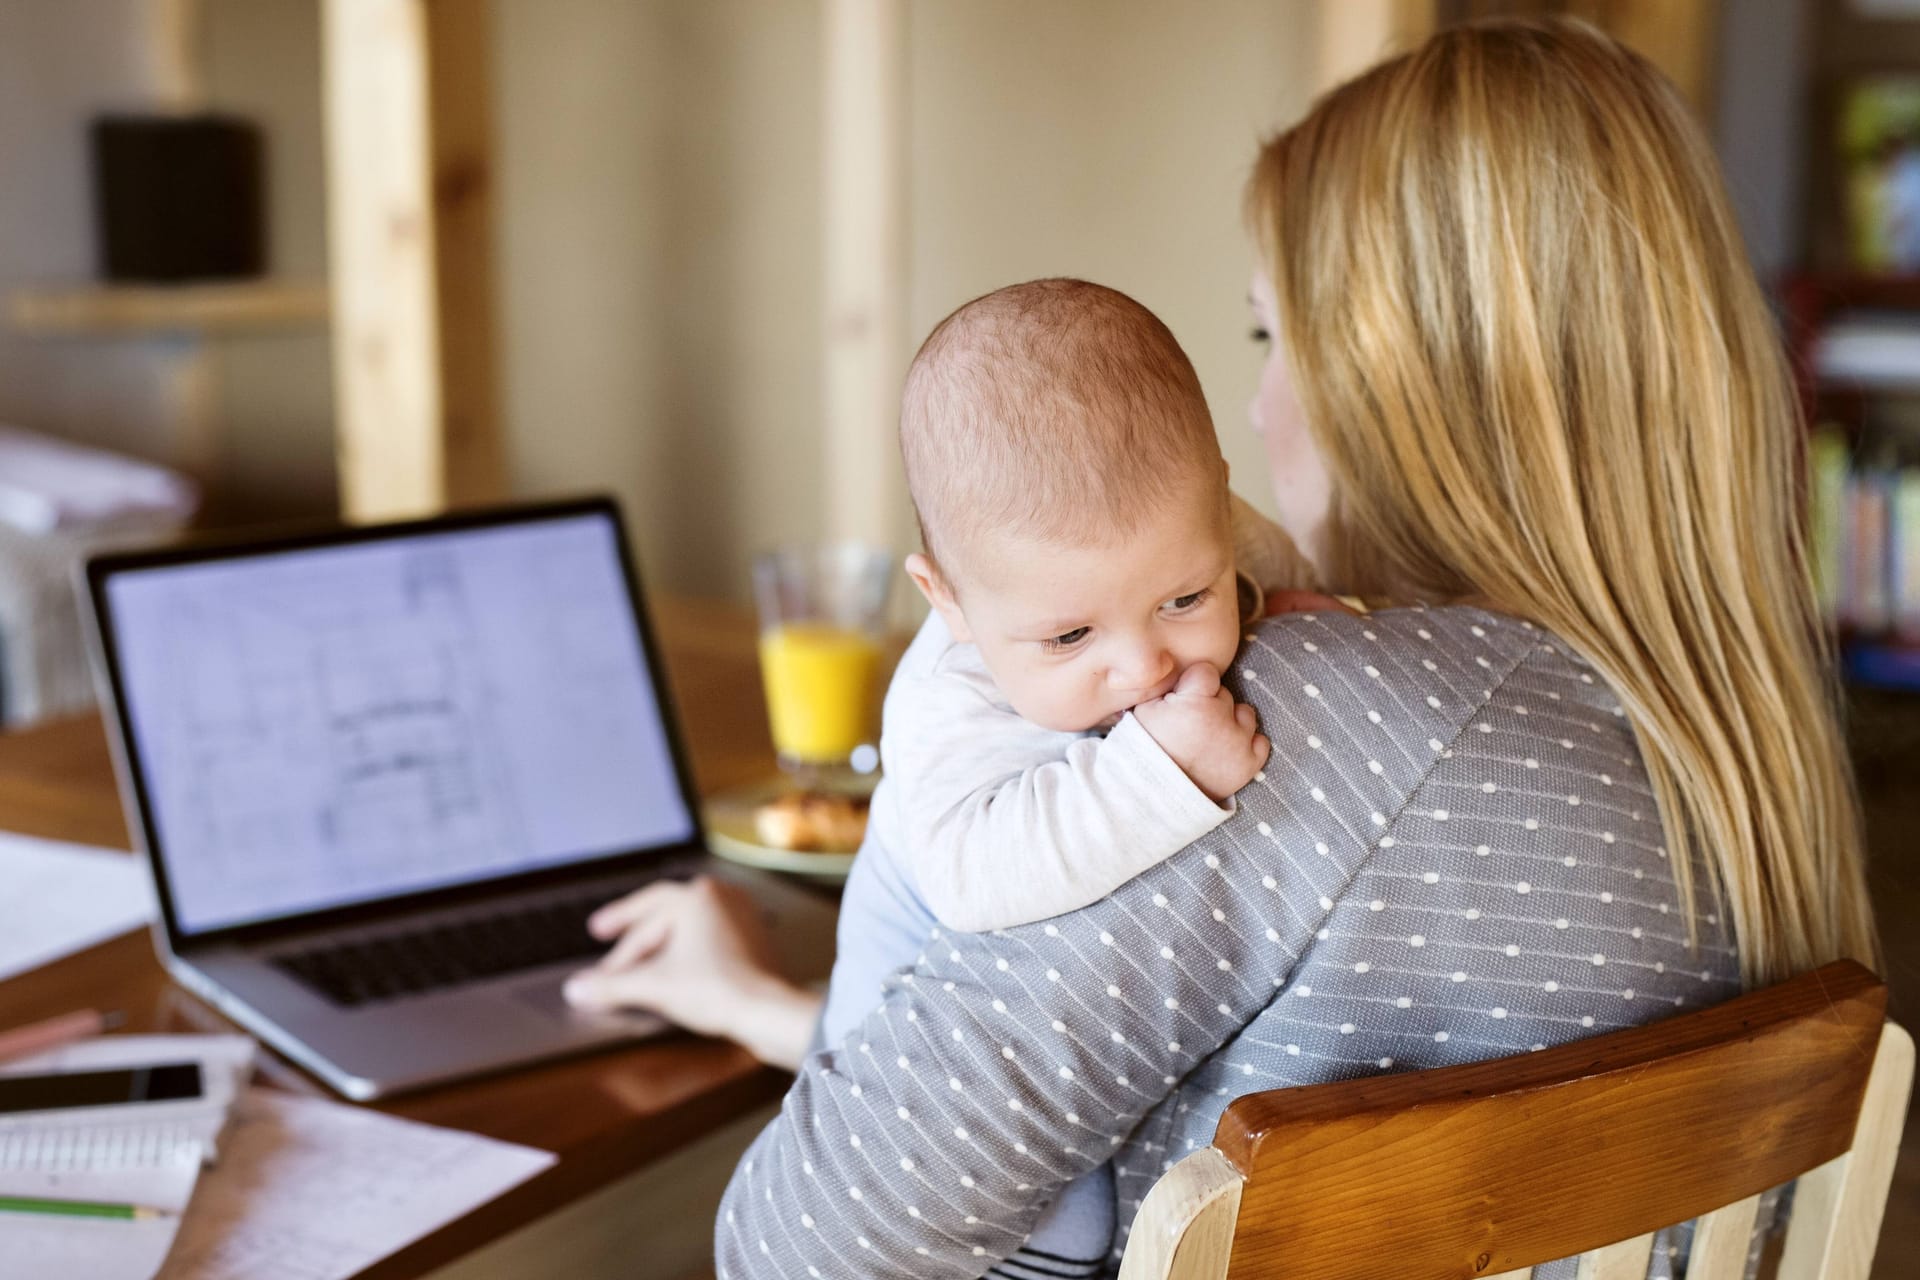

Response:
(564, 875), (820, 1071)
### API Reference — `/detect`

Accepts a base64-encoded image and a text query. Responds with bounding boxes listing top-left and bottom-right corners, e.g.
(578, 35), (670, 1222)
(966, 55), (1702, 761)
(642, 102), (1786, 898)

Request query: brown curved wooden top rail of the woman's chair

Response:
(1215, 961), (1885, 1280)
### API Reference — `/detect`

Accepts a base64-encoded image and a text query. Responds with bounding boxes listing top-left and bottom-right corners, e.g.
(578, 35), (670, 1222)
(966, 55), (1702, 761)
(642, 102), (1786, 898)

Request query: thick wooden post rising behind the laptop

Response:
(323, 0), (505, 520)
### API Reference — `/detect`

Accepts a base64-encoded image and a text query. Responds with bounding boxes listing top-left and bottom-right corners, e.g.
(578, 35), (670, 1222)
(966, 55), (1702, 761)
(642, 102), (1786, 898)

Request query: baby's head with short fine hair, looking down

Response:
(900, 280), (1240, 731)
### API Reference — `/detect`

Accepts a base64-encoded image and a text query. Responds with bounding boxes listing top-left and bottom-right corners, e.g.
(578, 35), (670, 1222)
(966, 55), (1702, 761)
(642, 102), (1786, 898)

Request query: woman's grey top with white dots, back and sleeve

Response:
(716, 608), (1740, 1280)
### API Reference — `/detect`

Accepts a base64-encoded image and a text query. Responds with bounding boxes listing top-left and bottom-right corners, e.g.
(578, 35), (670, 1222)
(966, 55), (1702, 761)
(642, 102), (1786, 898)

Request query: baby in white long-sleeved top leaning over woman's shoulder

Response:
(822, 280), (1300, 1276)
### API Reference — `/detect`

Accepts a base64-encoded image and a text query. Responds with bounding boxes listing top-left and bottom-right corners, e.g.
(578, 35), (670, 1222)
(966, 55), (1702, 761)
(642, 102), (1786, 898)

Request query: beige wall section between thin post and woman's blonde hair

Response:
(908, 0), (1317, 545)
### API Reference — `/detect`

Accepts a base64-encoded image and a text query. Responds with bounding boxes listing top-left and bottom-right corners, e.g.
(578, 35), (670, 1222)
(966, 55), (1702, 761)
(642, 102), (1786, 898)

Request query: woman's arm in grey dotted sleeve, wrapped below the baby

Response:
(716, 612), (1500, 1280)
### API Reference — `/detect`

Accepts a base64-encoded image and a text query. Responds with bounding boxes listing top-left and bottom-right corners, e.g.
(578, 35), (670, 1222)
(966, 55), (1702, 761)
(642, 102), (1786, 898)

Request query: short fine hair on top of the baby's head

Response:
(900, 278), (1227, 578)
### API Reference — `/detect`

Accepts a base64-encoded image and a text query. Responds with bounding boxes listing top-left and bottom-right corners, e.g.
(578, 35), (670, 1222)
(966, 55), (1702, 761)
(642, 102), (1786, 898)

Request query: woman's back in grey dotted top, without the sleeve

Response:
(1116, 608), (1740, 1274)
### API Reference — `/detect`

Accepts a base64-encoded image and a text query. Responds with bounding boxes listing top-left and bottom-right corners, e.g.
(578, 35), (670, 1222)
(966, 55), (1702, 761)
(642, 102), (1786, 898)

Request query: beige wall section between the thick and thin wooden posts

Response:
(493, 0), (820, 599)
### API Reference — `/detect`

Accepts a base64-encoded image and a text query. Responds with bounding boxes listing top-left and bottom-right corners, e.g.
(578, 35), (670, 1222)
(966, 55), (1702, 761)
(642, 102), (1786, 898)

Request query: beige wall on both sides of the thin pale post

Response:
(493, 0), (1313, 597)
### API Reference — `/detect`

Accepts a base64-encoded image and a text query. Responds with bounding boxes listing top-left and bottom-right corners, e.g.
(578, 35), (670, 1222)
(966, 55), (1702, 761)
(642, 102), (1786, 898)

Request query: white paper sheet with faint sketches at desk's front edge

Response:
(159, 1088), (553, 1280)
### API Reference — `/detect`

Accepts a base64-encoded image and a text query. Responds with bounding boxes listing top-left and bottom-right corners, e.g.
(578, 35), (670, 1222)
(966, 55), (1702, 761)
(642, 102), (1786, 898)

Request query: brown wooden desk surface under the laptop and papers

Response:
(0, 601), (810, 1280)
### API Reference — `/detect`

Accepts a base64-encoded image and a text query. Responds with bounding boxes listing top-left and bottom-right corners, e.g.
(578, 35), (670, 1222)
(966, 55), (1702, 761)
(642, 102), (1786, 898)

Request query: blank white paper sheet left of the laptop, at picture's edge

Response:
(0, 831), (156, 981)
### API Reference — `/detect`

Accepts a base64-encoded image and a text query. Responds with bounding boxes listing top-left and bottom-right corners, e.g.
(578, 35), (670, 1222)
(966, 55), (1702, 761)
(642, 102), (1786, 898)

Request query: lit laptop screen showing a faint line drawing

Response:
(104, 512), (695, 933)
